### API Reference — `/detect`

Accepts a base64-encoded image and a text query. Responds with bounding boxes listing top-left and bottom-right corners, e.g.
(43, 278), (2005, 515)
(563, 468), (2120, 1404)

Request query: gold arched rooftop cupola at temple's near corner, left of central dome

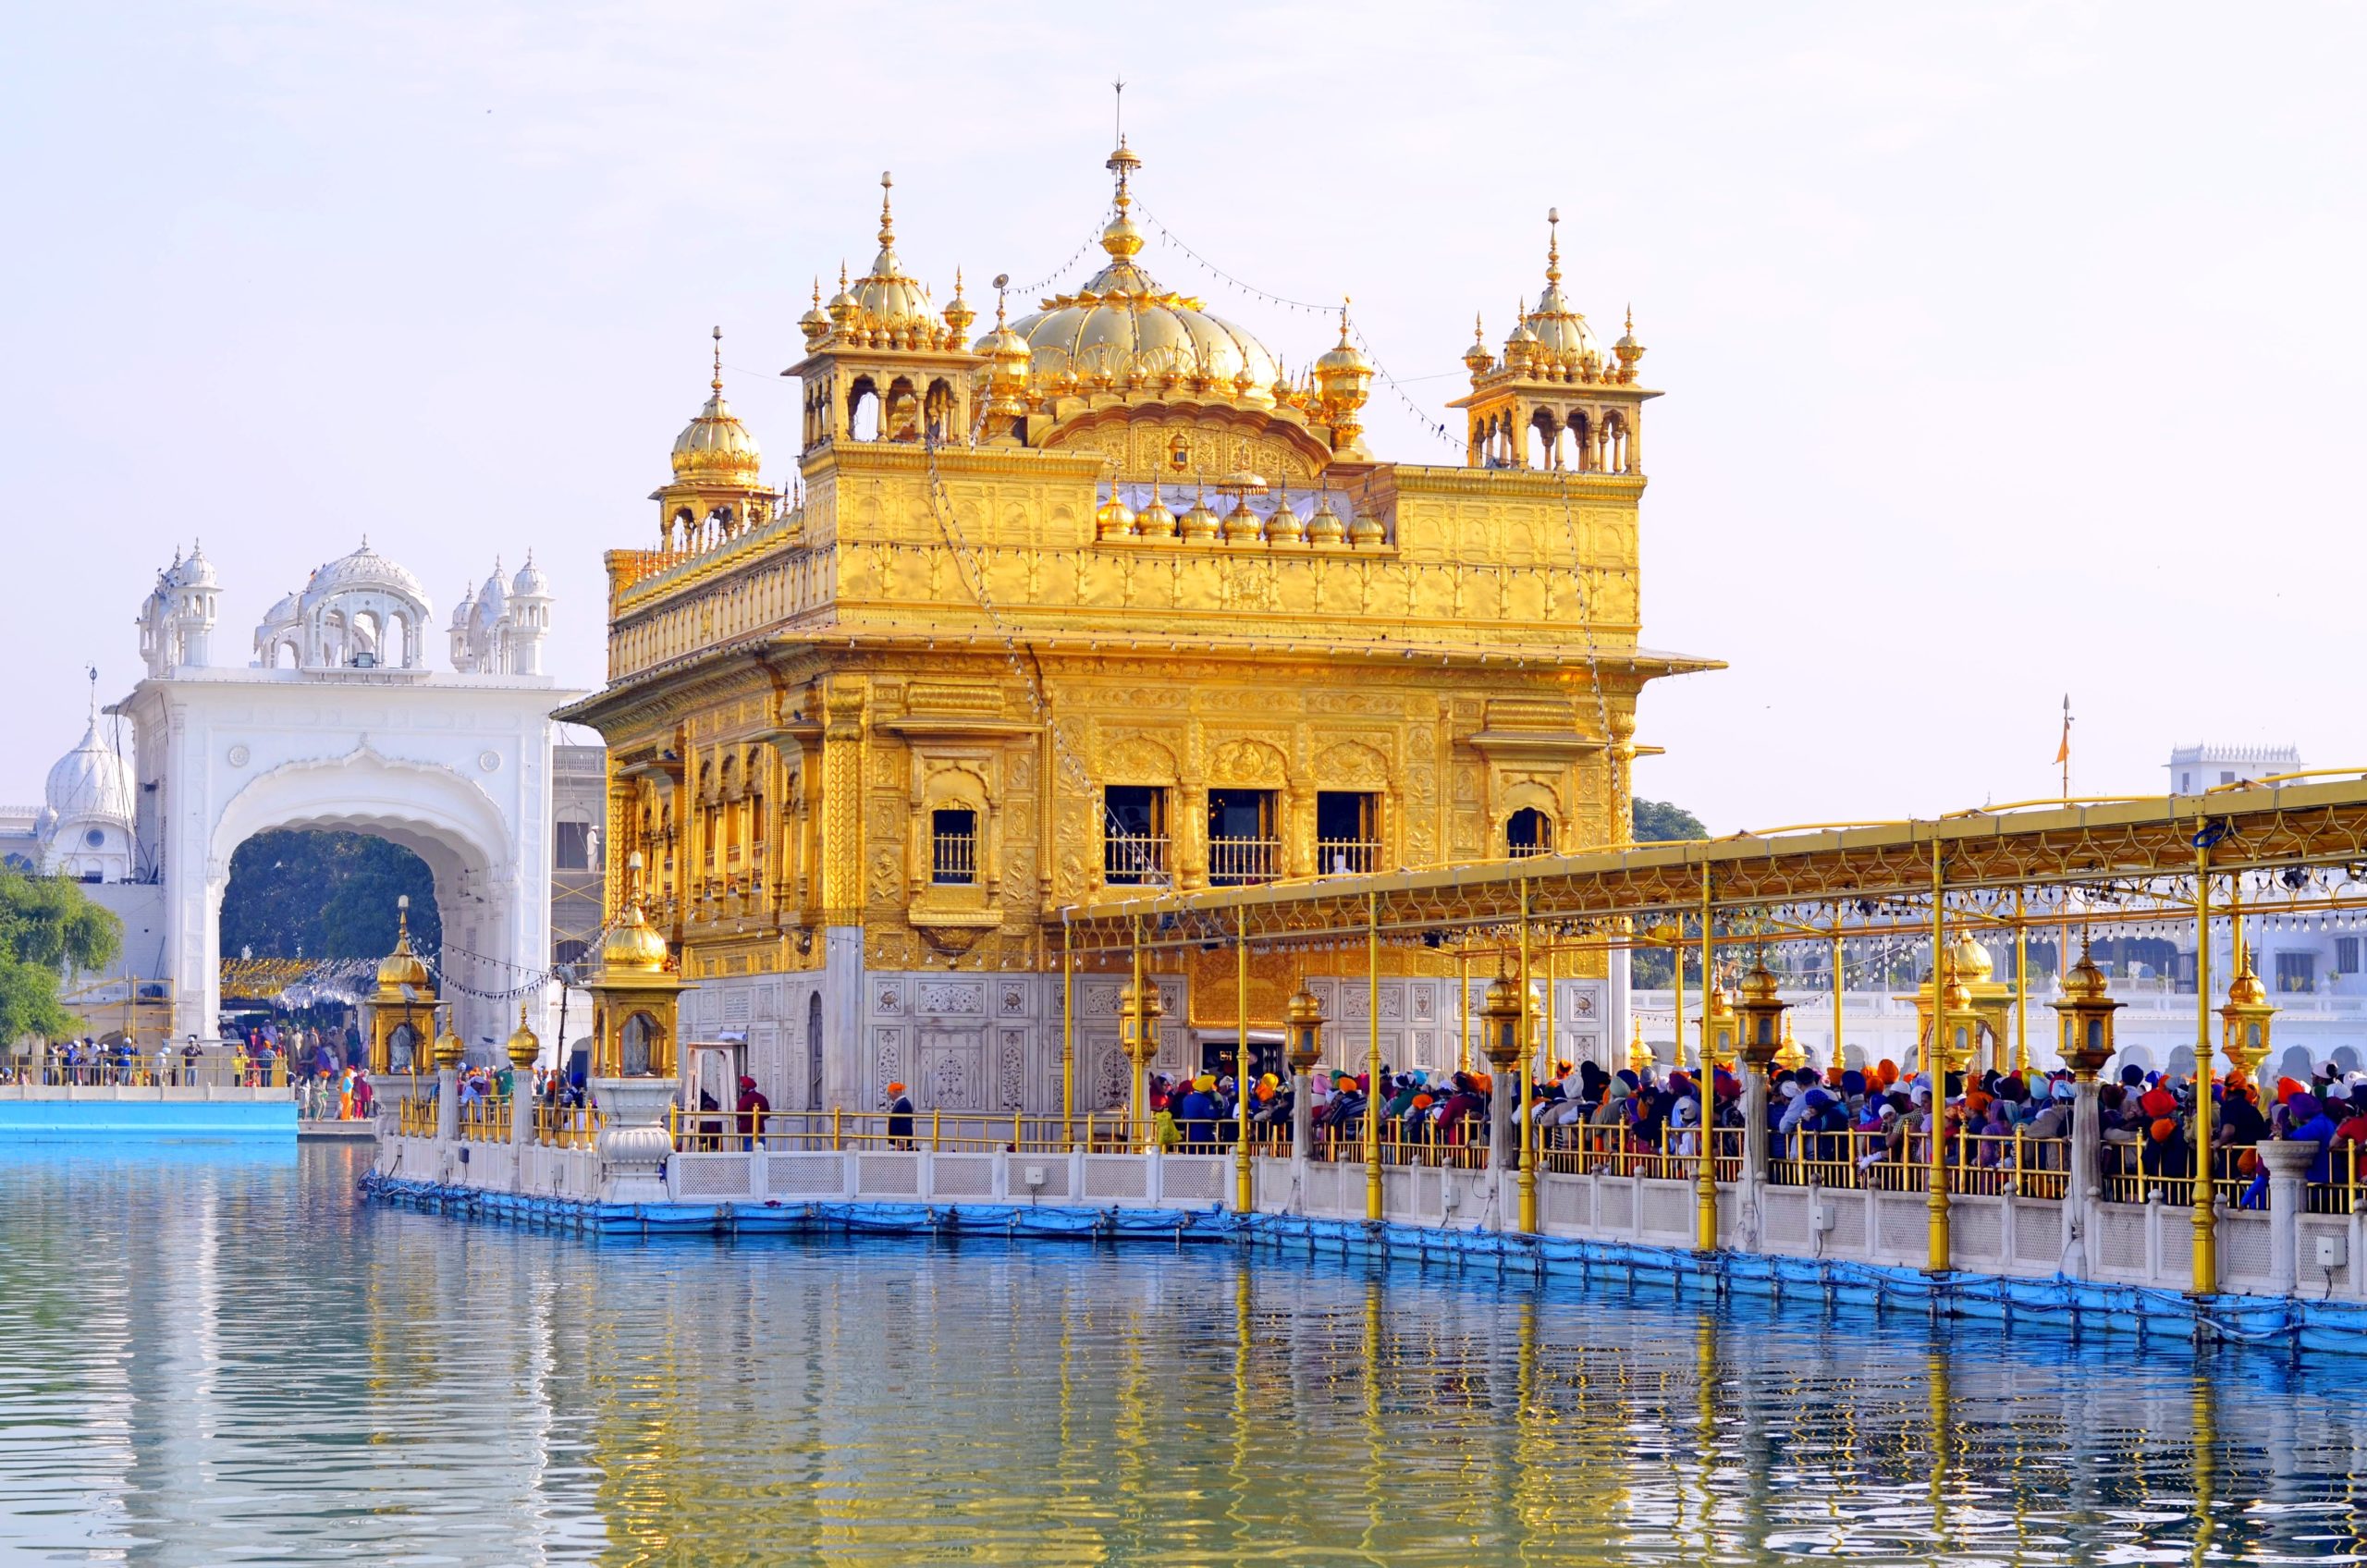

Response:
(781, 173), (982, 455)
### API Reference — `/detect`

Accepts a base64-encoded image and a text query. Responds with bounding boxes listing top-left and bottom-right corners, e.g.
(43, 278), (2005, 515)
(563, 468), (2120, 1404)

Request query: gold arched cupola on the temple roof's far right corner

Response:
(1449, 208), (1660, 476)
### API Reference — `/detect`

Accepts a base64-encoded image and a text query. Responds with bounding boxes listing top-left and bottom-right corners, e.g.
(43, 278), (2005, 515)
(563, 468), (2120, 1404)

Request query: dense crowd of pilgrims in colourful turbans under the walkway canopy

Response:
(1131, 1059), (2367, 1201)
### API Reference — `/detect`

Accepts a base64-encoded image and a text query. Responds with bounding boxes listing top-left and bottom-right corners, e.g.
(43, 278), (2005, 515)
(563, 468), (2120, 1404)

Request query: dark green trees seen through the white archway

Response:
(223, 829), (443, 960)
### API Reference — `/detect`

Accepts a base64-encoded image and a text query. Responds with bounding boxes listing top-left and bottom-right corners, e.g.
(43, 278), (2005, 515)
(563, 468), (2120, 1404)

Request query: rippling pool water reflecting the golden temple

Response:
(0, 1149), (2367, 1565)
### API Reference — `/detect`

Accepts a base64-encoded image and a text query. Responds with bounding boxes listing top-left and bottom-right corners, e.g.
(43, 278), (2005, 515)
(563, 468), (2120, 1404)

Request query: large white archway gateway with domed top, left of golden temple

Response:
(118, 545), (573, 1061)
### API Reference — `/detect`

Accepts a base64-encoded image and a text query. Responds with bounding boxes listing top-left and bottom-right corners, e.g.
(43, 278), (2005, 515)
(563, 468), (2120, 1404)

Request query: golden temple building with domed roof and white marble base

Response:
(568, 147), (1711, 1111)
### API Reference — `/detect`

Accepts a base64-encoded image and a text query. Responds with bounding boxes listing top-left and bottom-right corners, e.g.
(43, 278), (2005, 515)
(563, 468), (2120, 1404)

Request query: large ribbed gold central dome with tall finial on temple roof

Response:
(1011, 147), (1283, 408)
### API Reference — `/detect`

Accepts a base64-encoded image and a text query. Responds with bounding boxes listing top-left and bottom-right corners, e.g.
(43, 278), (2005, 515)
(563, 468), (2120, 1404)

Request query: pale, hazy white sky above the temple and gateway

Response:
(0, 0), (2367, 831)
